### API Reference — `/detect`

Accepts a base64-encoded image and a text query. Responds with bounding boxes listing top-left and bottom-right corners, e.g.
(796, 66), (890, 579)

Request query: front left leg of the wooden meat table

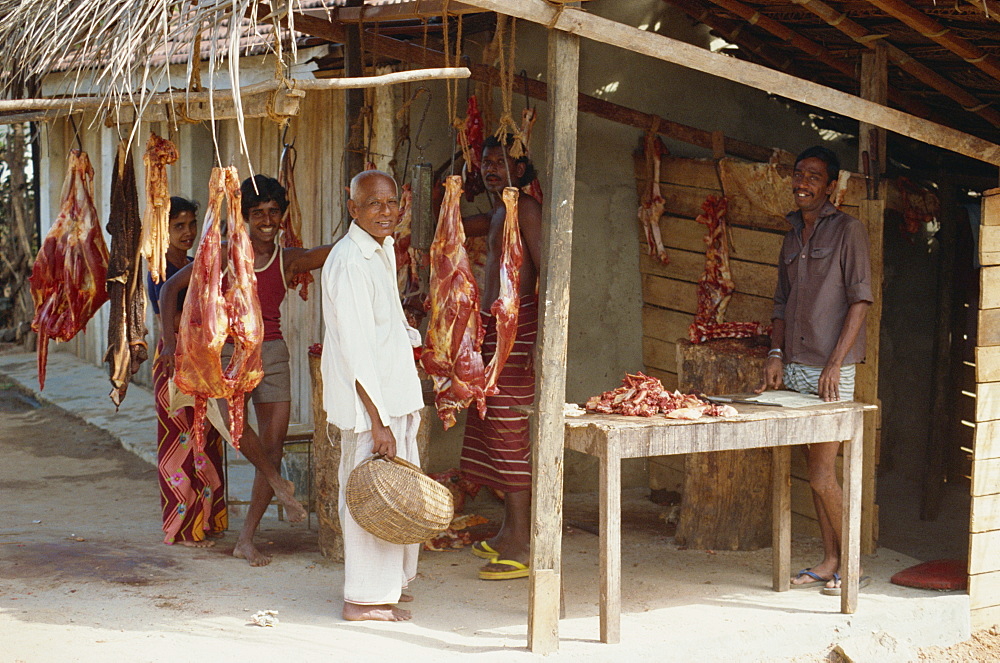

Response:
(600, 452), (622, 644)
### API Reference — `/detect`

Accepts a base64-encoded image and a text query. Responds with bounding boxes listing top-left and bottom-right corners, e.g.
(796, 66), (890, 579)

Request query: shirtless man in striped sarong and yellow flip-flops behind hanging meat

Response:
(461, 135), (542, 580)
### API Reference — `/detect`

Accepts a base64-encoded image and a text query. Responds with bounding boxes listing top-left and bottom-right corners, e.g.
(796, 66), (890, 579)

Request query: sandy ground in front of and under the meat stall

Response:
(0, 358), (988, 663)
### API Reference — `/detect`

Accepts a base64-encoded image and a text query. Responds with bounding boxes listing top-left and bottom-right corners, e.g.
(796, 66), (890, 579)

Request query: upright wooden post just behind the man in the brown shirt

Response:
(854, 45), (888, 554)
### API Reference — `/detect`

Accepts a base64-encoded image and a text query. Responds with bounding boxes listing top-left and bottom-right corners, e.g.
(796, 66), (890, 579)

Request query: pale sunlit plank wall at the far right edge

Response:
(969, 189), (1000, 629)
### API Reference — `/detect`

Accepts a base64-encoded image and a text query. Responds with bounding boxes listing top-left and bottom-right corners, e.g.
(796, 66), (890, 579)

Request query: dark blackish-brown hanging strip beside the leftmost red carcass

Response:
(104, 142), (149, 409)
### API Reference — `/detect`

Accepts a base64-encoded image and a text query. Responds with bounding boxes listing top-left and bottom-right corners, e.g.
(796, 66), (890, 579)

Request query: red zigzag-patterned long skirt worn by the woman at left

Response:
(153, 341), (229, 543)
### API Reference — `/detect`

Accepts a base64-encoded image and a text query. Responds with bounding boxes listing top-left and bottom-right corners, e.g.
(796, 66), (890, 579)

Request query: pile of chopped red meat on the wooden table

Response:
(586, 373), (738, 419)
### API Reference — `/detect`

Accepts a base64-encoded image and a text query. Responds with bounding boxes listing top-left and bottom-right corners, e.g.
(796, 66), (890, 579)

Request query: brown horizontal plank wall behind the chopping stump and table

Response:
(636, 156), (881, 547)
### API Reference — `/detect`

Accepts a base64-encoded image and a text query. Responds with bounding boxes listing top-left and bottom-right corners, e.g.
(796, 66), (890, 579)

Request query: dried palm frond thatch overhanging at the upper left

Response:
(0, 0), (324, 154)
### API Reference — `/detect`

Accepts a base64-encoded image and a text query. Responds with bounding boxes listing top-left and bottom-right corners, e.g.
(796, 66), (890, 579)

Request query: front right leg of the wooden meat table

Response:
(840, 411), (864, 614)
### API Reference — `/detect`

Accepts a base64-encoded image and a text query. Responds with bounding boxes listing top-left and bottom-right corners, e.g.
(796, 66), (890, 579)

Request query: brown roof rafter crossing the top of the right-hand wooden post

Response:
(792, 0), (1000, 127)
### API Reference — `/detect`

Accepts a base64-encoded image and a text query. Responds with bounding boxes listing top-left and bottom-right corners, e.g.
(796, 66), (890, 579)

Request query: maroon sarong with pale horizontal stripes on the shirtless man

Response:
(460, 295), (538, 493)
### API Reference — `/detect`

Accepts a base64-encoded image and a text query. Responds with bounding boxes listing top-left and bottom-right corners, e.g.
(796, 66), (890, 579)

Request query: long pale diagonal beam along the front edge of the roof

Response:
(456, 0), (1000, 165)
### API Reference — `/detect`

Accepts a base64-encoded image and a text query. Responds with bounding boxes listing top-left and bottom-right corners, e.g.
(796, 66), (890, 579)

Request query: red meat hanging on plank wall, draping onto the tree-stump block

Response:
(688, 196), (767, 343)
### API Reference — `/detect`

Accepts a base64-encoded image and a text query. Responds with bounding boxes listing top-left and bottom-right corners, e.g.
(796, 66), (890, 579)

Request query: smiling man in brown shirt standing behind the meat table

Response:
(759, 147), (872, 595)
